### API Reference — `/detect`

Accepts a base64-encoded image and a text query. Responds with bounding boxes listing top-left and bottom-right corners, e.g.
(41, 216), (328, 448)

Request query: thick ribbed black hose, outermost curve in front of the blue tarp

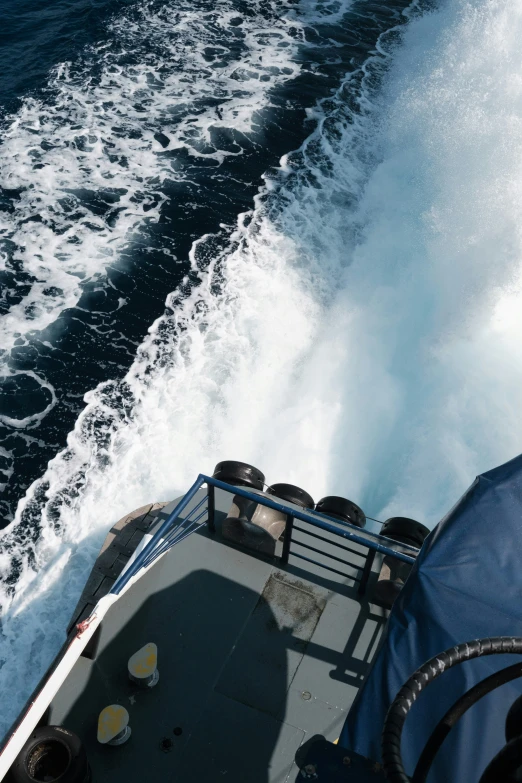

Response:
(382, 636), (522, 783)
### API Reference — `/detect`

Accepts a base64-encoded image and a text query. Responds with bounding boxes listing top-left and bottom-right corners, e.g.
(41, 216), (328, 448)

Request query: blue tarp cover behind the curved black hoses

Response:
(340, 455), (522, 783)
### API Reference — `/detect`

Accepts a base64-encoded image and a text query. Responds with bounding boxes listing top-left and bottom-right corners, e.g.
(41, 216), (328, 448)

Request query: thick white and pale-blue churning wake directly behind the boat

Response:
(0, 0), (522, 740)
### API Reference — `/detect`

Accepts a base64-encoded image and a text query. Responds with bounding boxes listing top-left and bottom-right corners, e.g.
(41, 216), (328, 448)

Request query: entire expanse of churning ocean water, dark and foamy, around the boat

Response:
(0, 0), (522, 733)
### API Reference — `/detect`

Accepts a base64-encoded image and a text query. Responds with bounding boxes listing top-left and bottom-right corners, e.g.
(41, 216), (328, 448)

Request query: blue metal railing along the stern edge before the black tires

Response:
(110, 474), (418, 595)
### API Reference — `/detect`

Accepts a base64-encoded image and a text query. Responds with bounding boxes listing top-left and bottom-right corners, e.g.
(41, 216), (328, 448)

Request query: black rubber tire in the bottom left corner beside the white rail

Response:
(9, 726), (91, 783)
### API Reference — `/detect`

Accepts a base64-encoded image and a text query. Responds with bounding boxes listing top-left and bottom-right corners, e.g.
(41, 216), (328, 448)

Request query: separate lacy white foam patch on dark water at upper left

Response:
(0, 0), (308, 360)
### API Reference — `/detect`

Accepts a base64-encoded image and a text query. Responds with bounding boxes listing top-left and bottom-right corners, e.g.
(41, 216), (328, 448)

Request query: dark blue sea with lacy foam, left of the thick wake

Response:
(0, 0), (406, 525)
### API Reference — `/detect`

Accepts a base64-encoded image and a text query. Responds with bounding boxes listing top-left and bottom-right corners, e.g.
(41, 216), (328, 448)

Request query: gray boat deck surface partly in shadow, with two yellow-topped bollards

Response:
(50, 491), (384, 783)
